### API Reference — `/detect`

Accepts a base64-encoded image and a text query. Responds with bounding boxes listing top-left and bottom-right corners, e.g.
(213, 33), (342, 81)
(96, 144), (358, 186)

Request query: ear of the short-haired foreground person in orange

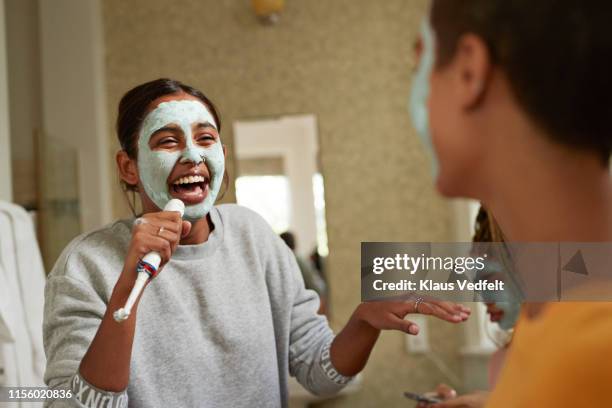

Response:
(453, 34), (492, 109)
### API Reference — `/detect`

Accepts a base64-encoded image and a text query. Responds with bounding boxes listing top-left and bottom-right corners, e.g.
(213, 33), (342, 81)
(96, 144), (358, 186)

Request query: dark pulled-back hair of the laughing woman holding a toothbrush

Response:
(117, 78), (221, 159)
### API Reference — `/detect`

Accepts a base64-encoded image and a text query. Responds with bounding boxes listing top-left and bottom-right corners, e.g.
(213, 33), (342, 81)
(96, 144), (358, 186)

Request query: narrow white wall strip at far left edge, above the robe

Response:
(0, 0), (13, 201)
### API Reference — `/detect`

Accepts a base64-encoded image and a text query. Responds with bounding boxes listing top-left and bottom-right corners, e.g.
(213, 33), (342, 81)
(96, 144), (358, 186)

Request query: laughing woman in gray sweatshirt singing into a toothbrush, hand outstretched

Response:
(44, 79), (469, 408)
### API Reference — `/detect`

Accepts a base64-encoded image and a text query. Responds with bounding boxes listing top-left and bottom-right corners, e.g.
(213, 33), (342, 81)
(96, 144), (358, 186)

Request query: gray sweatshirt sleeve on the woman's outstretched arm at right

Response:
(286, 245), (352, 396)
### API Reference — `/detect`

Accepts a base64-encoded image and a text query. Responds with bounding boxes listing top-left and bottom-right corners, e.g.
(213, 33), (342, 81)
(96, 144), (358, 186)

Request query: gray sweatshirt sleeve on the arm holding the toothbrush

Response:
(43, 270), (128, 408)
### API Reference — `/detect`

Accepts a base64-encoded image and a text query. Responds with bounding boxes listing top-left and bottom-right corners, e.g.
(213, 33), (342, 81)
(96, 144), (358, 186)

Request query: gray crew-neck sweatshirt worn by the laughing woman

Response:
(43, 205), (349, 408)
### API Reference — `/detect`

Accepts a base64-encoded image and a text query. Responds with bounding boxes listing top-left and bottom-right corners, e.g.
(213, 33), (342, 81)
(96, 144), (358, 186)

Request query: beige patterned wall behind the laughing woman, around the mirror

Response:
(104, 0), (462, 407)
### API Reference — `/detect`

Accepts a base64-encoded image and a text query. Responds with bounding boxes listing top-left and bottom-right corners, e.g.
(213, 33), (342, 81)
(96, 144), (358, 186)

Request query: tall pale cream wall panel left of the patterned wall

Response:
(38, 0), (111, 230)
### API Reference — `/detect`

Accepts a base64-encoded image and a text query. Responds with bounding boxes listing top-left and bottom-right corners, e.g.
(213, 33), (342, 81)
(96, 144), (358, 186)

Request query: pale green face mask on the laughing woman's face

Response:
(138, 100), (225, 221)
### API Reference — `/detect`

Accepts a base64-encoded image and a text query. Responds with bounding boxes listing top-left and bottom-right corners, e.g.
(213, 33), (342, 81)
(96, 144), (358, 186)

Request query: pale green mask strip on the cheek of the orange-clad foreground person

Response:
(410, 17), (439, 176)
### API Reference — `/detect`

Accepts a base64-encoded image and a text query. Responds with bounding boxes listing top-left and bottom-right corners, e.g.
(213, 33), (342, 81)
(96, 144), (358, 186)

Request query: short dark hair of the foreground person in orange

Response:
(431, 0), (612, 165)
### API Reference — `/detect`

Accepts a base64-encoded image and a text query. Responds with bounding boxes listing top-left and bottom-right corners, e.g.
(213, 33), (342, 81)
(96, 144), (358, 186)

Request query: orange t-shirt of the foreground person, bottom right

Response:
(486, 302), (612, 408)
